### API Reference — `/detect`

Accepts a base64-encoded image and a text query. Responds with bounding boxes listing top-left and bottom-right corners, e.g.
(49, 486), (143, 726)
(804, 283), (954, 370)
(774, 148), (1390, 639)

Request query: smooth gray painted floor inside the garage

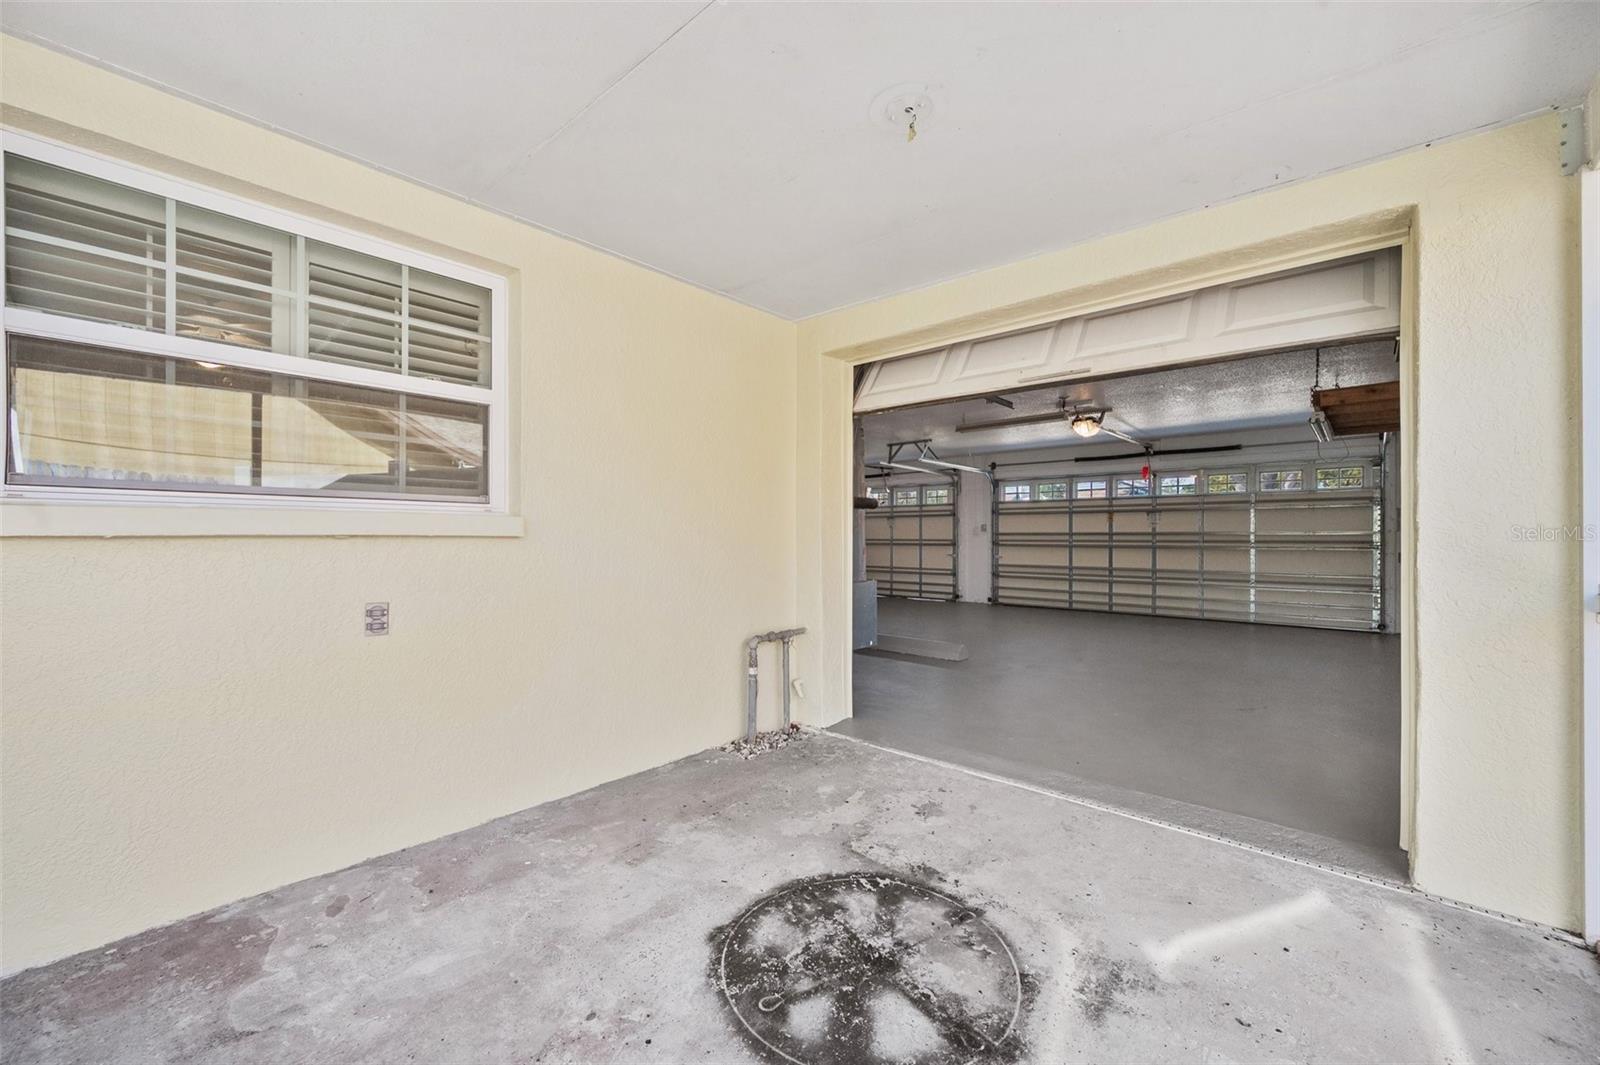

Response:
(835, 600), (1406, 880)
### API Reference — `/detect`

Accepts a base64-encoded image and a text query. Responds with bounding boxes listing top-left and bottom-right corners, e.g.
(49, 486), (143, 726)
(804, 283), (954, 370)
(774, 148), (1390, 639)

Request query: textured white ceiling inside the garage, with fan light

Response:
(859, 341), (1400, 462)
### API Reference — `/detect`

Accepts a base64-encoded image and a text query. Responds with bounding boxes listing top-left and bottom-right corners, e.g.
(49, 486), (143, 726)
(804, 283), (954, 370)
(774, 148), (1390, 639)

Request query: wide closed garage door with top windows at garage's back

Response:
(994, 461), (1382, 630)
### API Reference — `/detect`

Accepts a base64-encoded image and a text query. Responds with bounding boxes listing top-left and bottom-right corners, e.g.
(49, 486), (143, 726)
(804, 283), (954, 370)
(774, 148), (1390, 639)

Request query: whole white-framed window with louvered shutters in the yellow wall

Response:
(3, 138), (509, 510)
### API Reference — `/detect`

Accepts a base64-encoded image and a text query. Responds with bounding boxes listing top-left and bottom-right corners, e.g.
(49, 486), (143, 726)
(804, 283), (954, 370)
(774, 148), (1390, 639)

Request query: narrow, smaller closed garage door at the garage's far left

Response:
(866, 481), (958, 600)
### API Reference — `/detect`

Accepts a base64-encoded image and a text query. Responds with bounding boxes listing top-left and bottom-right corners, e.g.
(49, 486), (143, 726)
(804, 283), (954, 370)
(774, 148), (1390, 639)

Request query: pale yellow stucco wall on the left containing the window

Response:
(0, 38), (797, 972)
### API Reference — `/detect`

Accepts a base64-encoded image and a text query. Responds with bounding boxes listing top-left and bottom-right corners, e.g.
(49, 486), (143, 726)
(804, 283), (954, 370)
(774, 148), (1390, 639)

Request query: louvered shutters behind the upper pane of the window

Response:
(5, 154), (493, 387)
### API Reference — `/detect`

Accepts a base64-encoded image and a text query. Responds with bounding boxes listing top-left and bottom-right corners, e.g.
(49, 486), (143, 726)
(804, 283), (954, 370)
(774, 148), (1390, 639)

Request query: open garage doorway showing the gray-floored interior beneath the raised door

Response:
(835, 251), (1406, 880)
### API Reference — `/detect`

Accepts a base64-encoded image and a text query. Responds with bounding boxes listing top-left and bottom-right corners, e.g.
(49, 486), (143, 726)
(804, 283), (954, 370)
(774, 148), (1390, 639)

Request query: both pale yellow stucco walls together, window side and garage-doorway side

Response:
(0, 38), (1581, 971)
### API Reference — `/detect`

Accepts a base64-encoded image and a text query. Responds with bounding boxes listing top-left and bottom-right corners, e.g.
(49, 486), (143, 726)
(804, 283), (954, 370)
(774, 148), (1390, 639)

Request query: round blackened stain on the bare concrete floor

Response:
(712, 873), (1022, 1065)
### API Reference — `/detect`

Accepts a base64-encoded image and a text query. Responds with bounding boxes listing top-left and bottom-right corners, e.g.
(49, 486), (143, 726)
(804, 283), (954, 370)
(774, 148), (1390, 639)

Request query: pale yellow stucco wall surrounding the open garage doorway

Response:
(798, 115), (1582, 927)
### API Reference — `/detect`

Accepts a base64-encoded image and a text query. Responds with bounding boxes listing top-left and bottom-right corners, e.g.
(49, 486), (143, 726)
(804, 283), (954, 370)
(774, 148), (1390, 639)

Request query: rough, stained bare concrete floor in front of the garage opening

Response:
(0, 734), (1600, 1065)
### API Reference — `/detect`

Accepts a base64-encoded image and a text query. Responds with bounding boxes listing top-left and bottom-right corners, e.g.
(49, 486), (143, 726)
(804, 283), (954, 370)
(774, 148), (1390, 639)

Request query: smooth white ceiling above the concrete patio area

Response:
(0, 0), (1600, 317)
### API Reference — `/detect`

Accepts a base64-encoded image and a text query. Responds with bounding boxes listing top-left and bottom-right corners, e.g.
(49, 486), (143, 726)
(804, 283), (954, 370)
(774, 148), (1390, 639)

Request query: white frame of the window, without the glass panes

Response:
(0, 130), (508, 521)
